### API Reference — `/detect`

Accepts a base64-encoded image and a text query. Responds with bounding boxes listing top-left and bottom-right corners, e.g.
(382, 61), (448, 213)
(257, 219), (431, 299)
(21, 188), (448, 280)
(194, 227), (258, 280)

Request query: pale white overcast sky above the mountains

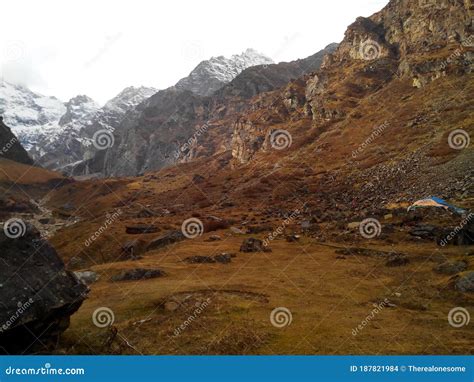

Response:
(0, 0), (388, 103)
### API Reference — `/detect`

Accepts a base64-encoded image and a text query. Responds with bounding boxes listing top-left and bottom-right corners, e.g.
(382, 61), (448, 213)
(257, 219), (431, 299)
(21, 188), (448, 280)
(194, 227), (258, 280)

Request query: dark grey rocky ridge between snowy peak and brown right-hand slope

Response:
(100, 44), (337, 176)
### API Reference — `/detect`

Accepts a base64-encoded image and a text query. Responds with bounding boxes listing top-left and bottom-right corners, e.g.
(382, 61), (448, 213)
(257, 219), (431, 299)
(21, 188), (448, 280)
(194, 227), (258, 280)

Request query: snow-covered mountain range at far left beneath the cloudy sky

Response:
(0, 81), (157, 169)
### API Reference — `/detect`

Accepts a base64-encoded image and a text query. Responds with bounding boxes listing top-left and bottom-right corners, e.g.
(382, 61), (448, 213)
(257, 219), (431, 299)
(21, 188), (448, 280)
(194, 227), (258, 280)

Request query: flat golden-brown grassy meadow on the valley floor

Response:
(58, 236), (474, 354)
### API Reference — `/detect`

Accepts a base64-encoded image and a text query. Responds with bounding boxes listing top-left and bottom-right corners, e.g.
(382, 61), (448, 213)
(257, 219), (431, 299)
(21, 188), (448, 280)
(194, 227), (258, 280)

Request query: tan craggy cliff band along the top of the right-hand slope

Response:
(232, 0), (474, 163)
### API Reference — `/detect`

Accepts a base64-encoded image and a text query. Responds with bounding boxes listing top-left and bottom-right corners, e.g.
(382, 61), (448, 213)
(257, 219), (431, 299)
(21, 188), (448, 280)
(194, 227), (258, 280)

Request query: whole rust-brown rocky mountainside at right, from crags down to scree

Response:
(232, 0), (474, 203)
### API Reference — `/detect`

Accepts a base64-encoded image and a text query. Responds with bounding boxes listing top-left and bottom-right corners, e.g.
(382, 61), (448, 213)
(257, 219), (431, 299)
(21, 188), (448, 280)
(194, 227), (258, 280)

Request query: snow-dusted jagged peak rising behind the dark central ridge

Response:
(176, 49), (273, 96)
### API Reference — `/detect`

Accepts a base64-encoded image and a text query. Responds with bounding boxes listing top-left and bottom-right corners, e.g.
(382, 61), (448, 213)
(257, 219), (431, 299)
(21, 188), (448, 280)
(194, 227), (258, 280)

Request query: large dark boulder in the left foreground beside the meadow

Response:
(0, 221), (88, 354)
